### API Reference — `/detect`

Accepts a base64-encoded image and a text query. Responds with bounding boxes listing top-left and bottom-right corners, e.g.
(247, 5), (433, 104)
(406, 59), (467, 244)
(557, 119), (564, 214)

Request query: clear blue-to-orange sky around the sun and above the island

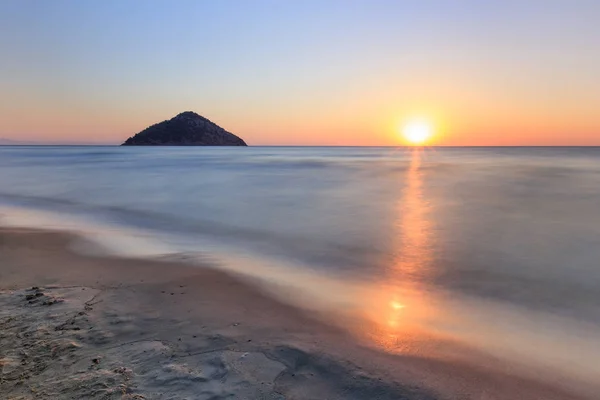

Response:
(0, 0), (600, 146)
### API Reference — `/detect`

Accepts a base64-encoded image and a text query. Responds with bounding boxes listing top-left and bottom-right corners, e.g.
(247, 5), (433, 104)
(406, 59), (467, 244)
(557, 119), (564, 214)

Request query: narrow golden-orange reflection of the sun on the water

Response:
(365, 147), (436, 352)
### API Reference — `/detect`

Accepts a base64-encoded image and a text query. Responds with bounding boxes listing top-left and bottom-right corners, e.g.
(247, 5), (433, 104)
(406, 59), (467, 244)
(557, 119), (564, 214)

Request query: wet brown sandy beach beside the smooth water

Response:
(0, 228), (593, 400)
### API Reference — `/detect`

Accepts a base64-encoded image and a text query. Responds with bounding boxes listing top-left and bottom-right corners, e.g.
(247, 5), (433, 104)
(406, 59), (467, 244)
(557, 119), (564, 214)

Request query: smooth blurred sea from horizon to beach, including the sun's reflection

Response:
(0, 146), (600, 388)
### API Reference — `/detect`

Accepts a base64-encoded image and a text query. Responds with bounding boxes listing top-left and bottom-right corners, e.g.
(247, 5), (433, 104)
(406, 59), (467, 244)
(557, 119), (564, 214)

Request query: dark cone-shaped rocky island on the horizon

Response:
(122, 111), (247, 146)
